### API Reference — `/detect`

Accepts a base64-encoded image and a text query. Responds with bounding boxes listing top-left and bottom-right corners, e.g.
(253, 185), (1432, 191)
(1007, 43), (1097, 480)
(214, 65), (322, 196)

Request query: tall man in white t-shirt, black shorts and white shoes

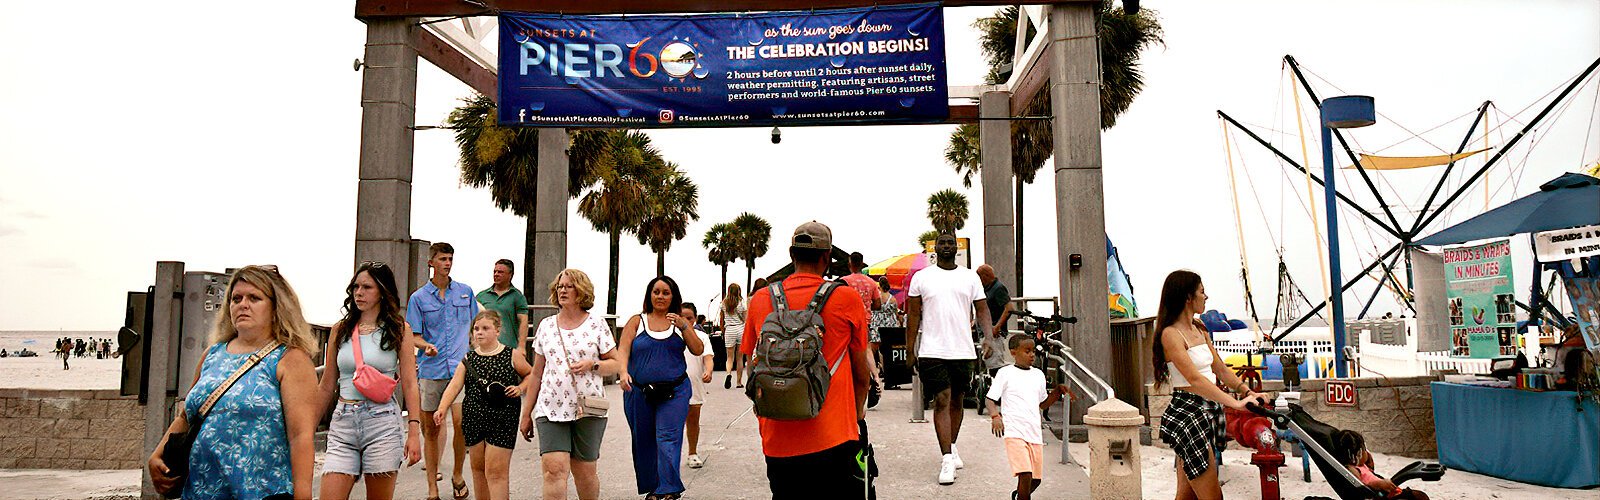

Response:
(906, 232), (994, 484)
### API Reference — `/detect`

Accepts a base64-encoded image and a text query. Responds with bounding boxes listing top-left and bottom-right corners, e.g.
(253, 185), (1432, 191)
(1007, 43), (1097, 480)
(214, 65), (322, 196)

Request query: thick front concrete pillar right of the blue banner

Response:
(1050, 3), (1110, 423)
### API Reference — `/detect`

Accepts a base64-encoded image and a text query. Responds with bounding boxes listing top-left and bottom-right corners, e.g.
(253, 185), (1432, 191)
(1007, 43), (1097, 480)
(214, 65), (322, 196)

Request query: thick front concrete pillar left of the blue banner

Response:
(355, 19), (427, 303)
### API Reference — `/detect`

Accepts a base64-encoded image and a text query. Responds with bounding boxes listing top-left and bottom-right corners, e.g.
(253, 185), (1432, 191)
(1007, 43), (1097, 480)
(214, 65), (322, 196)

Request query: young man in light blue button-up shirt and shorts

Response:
(405, 242), (478, 498)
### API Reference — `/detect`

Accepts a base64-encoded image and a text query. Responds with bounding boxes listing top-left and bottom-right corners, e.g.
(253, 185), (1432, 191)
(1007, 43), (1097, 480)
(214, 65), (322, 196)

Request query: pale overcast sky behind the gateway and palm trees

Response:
(0, 0), (1600, 330)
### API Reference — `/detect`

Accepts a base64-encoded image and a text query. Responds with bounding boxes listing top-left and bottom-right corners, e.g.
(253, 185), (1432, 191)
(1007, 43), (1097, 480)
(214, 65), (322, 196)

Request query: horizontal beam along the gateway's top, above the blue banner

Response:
(355, 0), (1101, 19)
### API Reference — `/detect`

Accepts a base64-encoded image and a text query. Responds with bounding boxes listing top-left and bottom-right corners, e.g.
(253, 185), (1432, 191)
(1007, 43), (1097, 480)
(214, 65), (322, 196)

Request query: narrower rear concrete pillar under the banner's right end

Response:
(978, 91), (1022, 296)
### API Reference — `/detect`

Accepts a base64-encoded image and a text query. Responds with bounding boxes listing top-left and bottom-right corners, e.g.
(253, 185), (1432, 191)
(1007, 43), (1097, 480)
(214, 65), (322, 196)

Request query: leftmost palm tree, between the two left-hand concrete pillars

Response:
(445, 95), (539, 290)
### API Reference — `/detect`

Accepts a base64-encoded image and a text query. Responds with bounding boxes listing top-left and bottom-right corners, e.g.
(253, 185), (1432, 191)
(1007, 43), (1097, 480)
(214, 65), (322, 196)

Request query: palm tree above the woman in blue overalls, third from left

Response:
(635, 162), (699, 276)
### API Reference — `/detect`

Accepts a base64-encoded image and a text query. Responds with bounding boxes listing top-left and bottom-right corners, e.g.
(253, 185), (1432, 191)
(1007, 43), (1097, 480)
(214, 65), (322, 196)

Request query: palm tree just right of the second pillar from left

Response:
(578, 130), (664, 314)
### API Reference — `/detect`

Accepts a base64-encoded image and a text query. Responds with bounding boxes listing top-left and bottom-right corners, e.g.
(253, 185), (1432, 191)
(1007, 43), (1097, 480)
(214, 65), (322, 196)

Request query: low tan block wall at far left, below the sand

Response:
(0, 389), (149, 470)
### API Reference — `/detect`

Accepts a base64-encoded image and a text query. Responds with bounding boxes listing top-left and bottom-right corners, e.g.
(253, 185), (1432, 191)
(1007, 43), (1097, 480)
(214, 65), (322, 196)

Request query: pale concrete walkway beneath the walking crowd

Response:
(18, 372), (1600, 500)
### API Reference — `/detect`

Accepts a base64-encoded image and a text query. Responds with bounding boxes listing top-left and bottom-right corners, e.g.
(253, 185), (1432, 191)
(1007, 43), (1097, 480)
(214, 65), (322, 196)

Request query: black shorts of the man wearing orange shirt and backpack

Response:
(766, 441), (869, 500)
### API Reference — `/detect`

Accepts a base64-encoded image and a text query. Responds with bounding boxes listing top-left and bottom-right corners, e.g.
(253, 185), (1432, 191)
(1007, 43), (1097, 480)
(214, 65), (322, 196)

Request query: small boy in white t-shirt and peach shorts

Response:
(984, 333), (1072, 500)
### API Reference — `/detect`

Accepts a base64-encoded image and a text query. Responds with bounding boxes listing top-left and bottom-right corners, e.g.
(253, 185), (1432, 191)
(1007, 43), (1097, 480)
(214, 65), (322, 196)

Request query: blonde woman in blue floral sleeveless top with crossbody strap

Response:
(147, 266), (318, 500)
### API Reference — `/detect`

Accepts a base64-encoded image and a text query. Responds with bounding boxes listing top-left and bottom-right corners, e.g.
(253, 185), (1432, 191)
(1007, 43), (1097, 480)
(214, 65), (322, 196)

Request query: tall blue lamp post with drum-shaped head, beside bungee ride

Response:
(1322, 96), (1378, 378)
